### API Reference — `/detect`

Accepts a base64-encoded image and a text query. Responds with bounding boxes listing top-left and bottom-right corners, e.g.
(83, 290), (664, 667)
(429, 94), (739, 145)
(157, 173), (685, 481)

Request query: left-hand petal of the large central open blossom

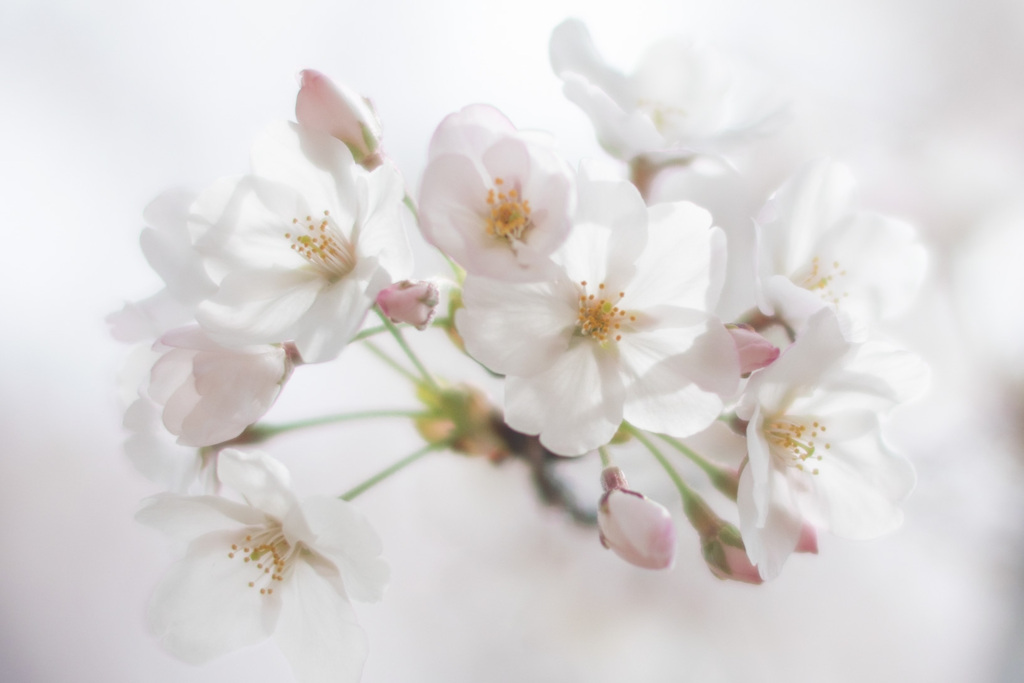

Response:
(456, 276), (579, 376)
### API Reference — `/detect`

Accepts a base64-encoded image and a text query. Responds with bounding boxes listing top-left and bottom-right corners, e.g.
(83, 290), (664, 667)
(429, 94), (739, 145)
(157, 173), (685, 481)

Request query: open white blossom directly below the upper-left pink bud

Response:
(190, 124), (412, 362)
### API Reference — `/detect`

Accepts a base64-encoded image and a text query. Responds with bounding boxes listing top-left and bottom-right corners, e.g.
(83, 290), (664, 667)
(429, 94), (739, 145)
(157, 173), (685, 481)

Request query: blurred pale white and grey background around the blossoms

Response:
(0, 0), (1024, 683)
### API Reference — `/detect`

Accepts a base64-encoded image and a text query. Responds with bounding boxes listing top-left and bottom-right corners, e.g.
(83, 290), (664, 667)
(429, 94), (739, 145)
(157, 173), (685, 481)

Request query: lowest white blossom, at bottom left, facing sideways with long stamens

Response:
(136, 449), (388, 683)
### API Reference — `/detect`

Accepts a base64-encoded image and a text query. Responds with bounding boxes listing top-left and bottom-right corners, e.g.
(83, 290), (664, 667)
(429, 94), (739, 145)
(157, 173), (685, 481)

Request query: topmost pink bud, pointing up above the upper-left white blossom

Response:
(295, 69), (381, 163)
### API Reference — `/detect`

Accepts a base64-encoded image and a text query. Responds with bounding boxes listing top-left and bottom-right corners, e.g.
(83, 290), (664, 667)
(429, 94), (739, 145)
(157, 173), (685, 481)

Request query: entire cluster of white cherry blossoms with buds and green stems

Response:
(110, 15), (927, 681)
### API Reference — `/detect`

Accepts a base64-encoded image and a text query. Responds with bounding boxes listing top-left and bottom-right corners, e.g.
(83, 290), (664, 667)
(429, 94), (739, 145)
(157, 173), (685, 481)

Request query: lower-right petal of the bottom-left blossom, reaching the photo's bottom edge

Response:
(274, 562), (368, 683)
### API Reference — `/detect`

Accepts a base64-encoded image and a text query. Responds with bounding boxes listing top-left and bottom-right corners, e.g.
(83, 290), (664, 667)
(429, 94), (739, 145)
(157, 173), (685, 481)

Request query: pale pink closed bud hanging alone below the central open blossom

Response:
(597, 467), (676, 569)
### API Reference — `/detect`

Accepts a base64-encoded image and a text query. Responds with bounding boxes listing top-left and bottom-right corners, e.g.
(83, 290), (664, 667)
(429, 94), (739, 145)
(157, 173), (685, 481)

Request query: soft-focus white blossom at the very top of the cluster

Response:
(550, 19), (781, 162)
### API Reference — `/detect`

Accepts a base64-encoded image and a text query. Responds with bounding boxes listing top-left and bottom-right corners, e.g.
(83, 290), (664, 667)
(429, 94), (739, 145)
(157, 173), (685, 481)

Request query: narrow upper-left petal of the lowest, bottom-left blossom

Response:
(135, 494), (266, 541)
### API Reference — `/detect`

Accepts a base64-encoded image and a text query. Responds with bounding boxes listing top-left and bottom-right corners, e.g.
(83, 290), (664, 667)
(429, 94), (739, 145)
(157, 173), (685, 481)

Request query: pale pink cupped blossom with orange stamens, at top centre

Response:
(420, 104), (572, 282)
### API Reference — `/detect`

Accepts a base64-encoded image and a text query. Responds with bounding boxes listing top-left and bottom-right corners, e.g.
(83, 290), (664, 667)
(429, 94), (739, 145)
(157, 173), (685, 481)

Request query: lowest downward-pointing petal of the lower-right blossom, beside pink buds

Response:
(736, 468), (804, 581)
